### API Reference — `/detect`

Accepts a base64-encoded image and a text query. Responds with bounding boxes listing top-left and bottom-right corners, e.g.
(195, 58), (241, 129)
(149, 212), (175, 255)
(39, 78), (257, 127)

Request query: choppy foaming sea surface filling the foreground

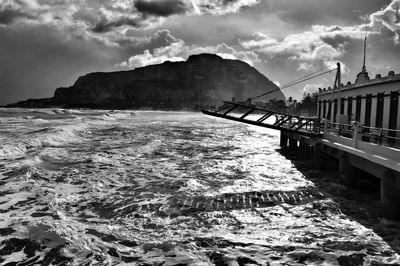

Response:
(0, 109), (400, 266)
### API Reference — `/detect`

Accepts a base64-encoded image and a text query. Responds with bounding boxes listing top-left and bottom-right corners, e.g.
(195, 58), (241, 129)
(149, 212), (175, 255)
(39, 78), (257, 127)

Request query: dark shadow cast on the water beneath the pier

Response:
(277, 149), (400, 254)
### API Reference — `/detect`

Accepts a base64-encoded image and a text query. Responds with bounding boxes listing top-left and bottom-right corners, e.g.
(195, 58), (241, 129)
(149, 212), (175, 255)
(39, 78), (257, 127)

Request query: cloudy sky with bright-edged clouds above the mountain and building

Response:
(0, 0), (400, 105)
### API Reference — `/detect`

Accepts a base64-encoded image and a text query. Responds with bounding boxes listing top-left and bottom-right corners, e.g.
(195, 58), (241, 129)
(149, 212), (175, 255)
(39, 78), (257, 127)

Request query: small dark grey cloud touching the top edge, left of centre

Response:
(134, 0), (188, 17)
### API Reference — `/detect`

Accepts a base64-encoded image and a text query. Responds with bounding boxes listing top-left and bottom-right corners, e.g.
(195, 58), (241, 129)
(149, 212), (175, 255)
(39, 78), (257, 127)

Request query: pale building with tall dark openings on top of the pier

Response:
(317, 68), (400, 134)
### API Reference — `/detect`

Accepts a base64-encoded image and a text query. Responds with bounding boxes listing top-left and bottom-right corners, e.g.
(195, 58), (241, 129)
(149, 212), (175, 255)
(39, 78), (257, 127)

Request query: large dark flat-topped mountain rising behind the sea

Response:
(9, 54), (285, 109)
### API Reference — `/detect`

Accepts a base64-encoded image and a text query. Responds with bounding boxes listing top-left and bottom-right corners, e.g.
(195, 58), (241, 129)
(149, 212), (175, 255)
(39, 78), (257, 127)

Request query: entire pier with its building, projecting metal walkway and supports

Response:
(202, 64), (400, 219)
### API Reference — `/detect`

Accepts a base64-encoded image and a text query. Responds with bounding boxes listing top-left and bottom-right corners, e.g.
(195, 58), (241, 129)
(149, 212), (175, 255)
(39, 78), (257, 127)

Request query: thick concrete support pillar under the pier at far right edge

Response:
(381, 170), (400, 219)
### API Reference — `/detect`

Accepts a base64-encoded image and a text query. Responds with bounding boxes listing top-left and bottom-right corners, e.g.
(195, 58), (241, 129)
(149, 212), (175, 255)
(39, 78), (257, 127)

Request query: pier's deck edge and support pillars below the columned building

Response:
(281, 132), (400, 219)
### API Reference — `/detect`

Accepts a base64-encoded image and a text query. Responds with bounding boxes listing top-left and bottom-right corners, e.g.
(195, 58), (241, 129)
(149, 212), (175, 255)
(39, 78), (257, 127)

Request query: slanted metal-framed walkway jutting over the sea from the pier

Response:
(201, 101), (322, 138)
